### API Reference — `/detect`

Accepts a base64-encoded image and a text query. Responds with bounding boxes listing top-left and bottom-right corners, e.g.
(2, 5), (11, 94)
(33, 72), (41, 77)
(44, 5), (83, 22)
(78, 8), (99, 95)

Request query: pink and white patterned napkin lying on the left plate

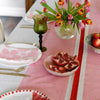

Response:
(0, 45), (39, 61)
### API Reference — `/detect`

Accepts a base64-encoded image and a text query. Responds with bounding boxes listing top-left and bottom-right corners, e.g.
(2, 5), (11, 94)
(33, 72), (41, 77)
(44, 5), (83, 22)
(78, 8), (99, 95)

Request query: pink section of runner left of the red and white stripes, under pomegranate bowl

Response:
(19, 23), (76, 100)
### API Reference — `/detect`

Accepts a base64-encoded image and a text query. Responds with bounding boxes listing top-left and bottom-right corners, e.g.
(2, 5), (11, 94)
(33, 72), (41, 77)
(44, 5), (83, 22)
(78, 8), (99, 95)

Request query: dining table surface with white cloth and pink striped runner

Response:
(0, 0), (100, 100)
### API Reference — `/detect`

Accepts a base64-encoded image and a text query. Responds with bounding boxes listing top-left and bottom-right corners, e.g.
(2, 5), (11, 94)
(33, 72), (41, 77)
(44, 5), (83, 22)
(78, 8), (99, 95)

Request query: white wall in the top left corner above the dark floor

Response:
(0, 0), (25, 16)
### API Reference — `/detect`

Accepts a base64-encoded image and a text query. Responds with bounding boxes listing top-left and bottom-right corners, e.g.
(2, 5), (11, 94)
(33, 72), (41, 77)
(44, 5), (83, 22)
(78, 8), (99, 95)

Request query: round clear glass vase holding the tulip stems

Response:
(55, 23), (76, 39)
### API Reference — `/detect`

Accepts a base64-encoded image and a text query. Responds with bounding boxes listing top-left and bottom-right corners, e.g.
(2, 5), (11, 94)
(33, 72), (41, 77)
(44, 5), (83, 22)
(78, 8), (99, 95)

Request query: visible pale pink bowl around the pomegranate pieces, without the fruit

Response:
(44, 55), (79, 76)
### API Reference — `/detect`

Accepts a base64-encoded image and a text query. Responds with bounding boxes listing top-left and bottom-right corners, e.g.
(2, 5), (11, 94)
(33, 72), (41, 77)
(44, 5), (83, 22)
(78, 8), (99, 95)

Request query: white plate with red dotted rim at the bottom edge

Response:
(0, 90), (49, 100)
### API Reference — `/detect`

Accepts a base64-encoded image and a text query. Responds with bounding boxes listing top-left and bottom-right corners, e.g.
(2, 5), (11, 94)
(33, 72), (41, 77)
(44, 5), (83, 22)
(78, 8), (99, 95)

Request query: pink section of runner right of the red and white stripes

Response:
(83, 0), (100, 100)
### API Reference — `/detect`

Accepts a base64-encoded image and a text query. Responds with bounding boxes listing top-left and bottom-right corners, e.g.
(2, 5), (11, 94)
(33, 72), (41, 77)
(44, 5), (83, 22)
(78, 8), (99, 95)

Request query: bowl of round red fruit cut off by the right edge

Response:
(86, 33), (100, 54)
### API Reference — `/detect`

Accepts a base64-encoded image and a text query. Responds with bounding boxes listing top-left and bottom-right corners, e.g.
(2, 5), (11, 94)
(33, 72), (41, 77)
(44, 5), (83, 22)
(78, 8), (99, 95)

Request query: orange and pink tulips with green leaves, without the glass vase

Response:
(36, 0), (92, 30)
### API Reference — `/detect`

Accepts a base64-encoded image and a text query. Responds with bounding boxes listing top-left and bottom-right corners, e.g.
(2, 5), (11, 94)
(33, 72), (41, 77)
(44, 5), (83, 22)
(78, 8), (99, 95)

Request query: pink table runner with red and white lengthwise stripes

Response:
(18, 0), (100, 100)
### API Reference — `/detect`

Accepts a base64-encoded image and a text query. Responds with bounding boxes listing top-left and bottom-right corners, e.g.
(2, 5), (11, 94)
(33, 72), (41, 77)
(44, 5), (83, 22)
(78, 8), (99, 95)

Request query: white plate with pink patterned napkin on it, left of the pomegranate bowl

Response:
(0, 43), (42, 67)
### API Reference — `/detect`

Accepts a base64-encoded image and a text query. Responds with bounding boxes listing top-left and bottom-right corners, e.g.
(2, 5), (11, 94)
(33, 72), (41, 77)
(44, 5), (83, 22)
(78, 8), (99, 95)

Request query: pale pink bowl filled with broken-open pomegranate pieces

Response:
(44, 52), (79, 76)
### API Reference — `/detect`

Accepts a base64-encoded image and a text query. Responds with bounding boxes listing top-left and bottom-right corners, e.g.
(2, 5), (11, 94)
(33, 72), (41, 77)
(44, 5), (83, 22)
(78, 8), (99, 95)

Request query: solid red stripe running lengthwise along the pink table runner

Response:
(70, 0), (88, 100)
